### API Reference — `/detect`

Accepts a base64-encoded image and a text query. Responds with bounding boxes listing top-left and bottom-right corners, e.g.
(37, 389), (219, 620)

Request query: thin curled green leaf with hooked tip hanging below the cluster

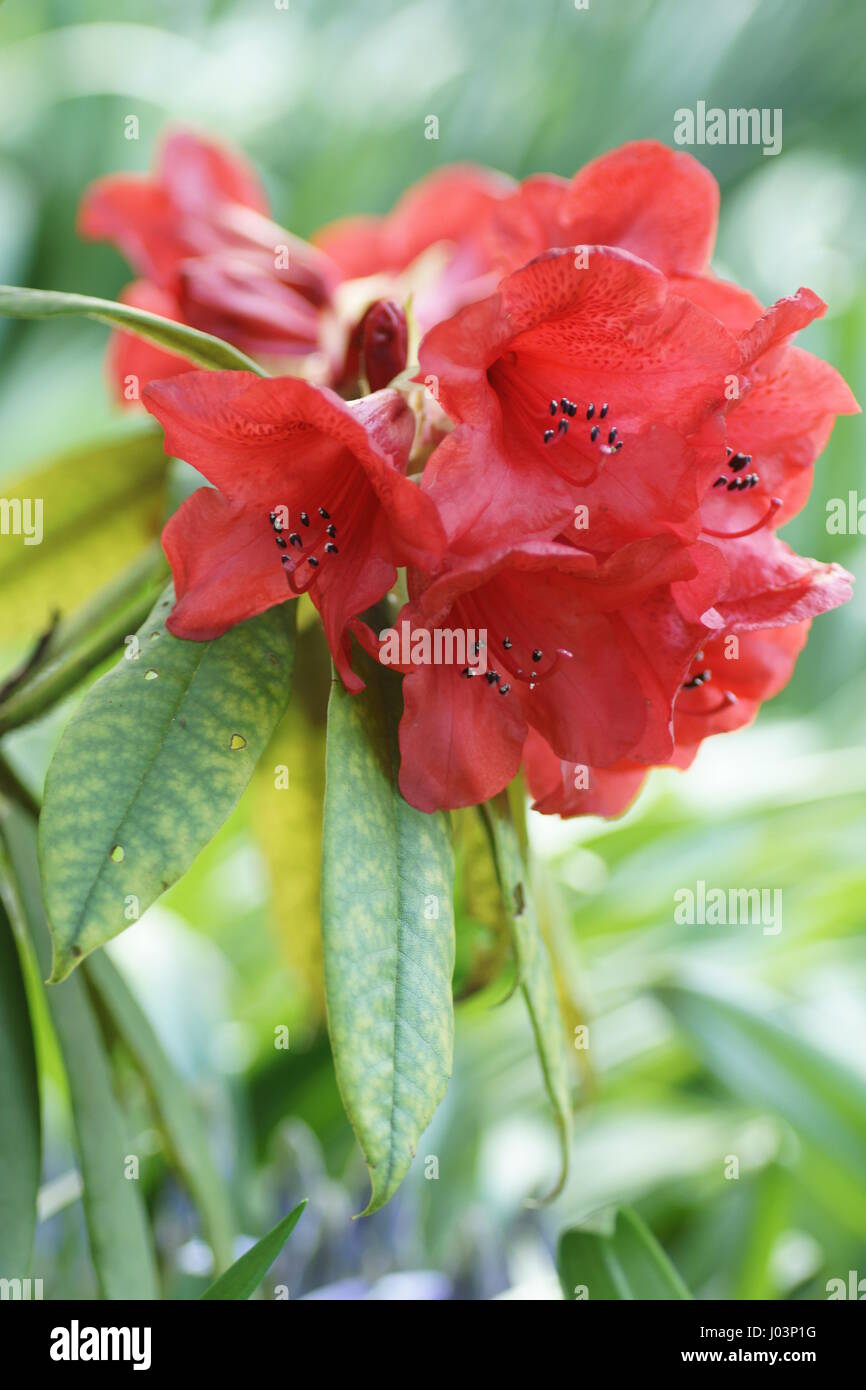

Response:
(485, 792), (571, 1201)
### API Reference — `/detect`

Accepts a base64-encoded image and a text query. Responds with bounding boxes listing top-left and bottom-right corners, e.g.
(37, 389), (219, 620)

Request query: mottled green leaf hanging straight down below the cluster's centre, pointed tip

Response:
(322, 660), (455, 1215)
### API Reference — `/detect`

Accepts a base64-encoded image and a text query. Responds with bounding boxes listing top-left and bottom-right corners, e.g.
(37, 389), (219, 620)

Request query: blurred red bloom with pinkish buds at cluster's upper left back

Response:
(79, 132), (339, 389)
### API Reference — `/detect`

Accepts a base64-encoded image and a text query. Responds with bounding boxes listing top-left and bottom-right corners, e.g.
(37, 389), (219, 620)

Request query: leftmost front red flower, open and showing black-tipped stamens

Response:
(145, 371), (443, 691)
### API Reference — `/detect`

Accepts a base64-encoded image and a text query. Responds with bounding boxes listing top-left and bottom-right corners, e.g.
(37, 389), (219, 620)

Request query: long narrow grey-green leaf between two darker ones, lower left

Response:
(3, 809), (157, 1298)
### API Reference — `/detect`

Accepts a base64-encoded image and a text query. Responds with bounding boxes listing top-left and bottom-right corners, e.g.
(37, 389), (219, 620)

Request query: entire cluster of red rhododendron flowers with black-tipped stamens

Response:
(82, 136), (858, 816)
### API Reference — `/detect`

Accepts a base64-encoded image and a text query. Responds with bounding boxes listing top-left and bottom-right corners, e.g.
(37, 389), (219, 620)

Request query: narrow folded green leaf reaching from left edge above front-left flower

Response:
(0, 285), (267, 377)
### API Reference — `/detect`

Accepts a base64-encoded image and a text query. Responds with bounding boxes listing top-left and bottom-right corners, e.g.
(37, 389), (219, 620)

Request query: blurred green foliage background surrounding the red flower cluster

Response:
(0, 0), (866, 1298)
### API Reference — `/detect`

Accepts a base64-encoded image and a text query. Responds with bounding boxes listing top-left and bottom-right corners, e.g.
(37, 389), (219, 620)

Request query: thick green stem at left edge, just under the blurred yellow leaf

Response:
(0, 541), (168, 735)
